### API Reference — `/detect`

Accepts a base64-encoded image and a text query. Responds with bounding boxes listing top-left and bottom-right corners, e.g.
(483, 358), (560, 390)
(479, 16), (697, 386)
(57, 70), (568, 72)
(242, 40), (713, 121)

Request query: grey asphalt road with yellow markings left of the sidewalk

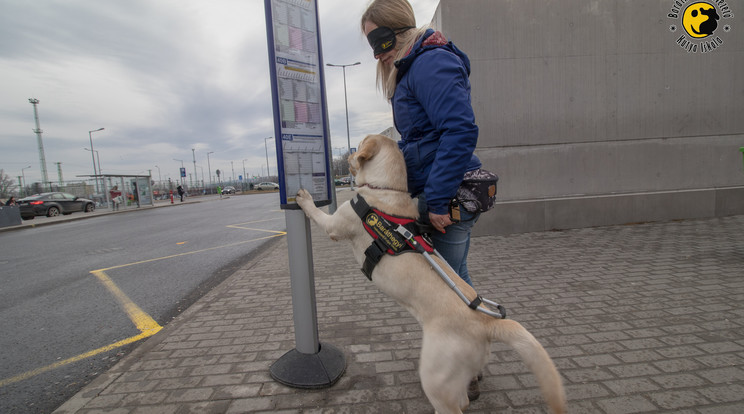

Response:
(0, 193), (286, 413)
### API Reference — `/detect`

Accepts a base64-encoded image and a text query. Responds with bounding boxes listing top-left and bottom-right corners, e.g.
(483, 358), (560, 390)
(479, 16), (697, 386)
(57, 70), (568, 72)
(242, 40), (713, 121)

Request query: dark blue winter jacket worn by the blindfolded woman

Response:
(392, 29), (481, 214)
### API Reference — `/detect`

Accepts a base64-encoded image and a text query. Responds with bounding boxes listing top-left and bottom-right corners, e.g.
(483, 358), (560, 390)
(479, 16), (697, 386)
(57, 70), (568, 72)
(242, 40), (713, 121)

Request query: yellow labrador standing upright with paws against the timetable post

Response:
(297, 135), (566, 414)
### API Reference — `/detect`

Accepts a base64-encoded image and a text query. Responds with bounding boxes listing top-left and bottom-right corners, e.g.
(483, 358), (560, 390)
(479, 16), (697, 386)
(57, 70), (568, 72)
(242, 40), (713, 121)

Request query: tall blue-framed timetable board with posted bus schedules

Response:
(265, 0), (332, 209)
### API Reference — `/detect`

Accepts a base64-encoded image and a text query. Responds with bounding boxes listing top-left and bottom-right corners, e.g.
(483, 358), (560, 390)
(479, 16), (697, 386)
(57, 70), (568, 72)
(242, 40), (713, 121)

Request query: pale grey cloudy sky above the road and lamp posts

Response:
(0, 0), (438, 188)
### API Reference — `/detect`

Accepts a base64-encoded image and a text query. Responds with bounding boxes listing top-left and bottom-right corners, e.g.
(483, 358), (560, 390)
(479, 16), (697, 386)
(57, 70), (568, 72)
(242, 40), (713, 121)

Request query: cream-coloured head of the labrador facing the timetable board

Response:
(349, 135), (408, 191)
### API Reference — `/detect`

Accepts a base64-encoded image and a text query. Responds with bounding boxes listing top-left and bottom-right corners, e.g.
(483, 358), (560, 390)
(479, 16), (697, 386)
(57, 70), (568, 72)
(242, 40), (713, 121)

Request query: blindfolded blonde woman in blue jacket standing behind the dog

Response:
(361, 0), (481, 400)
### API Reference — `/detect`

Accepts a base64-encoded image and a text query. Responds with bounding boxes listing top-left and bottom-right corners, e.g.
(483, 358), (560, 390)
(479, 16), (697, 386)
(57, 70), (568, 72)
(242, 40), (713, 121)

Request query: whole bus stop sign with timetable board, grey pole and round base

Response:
(264, 0), (346, 388)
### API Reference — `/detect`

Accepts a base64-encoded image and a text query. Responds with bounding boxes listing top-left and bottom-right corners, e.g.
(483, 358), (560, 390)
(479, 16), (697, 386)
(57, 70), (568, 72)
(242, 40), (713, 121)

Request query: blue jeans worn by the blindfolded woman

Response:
(418, 194), (480, 286)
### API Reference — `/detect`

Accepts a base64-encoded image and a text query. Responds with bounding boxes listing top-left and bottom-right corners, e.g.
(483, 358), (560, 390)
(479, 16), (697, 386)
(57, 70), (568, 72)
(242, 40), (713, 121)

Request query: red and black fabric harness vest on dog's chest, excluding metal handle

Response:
(351, 194), (434, 280)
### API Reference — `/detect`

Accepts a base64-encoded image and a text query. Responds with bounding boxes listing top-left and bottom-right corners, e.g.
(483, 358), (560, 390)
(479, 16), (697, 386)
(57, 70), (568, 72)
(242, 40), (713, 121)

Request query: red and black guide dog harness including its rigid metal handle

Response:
(351, 194), (506, 319)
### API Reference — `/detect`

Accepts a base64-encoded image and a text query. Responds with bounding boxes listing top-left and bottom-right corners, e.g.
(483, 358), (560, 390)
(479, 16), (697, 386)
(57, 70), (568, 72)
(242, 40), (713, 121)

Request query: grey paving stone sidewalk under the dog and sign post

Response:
(56, 192), (744, 414)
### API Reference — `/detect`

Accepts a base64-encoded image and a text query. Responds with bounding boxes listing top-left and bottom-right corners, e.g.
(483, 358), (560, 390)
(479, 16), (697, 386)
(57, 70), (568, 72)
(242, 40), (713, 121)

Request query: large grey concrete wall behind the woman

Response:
(432, 0), (744, 234)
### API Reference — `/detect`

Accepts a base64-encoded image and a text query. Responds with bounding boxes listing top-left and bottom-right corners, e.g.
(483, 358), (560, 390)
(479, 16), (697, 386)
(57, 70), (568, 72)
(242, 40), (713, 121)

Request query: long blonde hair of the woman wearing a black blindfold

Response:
(361, 0), (428, 100)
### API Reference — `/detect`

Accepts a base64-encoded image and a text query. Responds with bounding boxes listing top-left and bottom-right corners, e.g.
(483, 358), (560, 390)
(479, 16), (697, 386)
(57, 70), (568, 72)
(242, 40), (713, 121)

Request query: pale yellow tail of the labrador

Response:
(492, 319), (566, 414)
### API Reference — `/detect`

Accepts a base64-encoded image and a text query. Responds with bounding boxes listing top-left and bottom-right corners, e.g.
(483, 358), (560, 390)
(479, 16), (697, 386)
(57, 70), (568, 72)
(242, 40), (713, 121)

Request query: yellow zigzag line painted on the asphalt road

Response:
(0, 220), (287, 388)
